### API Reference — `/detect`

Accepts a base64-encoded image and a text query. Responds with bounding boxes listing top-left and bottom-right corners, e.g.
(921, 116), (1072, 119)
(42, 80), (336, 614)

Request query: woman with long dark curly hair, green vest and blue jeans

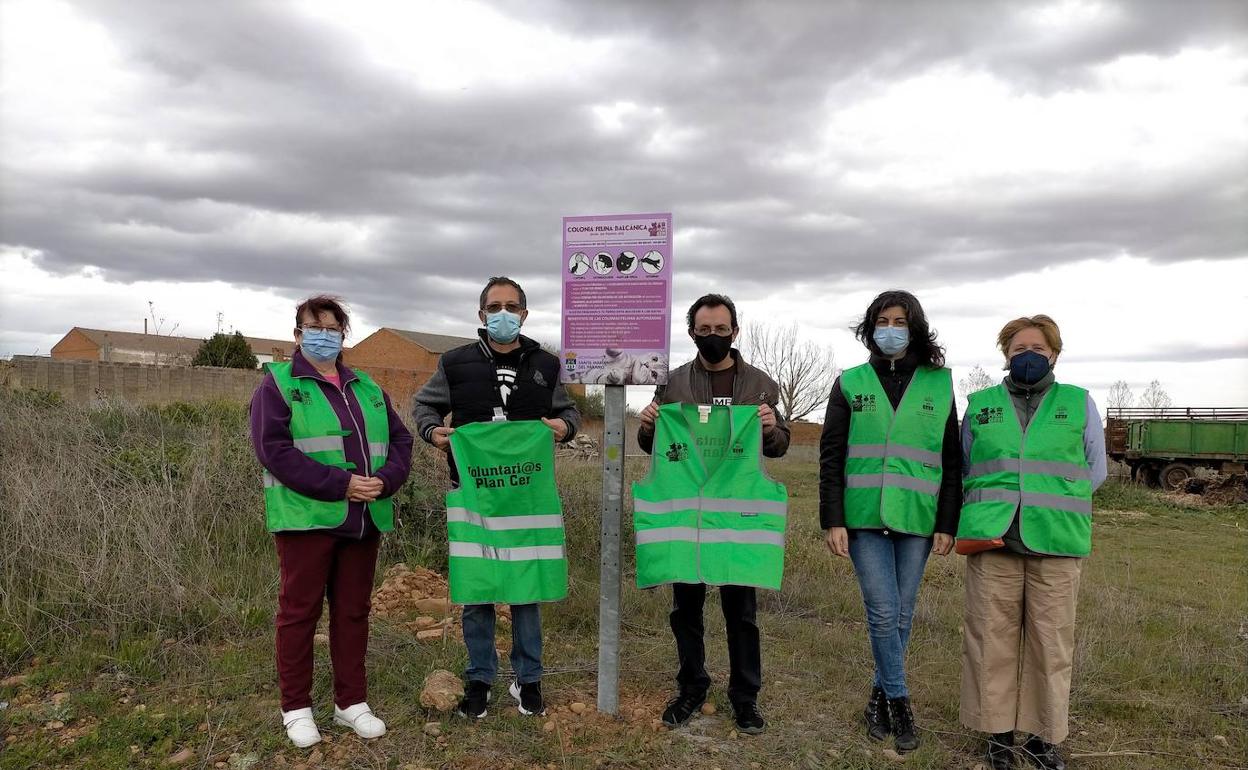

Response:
(819, 291), (962, 751)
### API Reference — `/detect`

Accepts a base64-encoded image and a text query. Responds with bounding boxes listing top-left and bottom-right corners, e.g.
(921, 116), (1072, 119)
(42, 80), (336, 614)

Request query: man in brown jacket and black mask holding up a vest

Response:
(636, 295), (789, 735)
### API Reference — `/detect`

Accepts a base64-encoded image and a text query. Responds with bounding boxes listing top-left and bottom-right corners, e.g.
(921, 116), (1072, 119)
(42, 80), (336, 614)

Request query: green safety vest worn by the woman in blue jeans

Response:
(841, 363), (953, 538)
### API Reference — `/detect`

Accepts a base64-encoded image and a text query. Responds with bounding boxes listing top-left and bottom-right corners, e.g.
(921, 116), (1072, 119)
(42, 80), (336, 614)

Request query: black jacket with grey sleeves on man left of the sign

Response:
(412, 329), (580, 479)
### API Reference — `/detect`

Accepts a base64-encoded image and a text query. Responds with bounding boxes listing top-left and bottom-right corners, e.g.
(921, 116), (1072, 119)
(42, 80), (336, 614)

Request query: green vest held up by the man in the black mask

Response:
(633, 403), (789, 590)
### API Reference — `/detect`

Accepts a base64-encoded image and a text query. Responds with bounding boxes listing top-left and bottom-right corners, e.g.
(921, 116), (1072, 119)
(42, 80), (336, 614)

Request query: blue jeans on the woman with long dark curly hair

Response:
(850, 529), (932, 698)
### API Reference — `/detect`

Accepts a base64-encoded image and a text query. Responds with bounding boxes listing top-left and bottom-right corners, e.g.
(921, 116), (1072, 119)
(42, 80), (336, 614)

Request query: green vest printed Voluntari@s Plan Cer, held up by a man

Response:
(447, 419), (568, 604)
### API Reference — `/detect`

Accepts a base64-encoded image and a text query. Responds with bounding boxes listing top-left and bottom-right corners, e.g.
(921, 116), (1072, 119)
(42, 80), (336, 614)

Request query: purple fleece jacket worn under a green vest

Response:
(251, 351), (412, 538)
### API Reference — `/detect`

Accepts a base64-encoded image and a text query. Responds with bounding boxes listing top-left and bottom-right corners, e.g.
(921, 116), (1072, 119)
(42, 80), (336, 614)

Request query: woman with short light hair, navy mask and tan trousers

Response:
(957, 316), (1106, 770)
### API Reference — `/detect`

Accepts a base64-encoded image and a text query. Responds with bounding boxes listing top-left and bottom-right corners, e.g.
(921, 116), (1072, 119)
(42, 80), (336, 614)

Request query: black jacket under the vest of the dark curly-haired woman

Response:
(819, 353), (962, 535)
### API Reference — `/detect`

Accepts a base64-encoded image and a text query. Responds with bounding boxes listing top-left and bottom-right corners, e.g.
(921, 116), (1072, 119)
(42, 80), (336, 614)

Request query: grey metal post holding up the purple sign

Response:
(598, 384), (628, 714)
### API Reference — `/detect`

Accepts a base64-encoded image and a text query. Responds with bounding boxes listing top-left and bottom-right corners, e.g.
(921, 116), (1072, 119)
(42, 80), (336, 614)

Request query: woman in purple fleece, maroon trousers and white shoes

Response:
(251, 296), (412, 748)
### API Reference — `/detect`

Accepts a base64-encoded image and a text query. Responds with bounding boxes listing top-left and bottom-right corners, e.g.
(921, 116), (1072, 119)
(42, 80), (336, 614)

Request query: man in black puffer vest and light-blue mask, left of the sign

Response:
(413, 277), (580, 719)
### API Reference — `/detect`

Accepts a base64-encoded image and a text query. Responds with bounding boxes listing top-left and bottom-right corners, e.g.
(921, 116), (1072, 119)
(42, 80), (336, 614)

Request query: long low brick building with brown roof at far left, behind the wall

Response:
(52, 326), (295, 366)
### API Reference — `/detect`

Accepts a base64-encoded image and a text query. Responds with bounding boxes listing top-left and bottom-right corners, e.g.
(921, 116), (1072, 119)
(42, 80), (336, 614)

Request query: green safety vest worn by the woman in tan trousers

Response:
(957, 383), (1092, 557)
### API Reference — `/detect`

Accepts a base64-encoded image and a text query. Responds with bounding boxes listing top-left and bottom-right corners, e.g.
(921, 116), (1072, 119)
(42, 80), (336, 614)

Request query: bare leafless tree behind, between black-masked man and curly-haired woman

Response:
(745, 323), (836, 421)
